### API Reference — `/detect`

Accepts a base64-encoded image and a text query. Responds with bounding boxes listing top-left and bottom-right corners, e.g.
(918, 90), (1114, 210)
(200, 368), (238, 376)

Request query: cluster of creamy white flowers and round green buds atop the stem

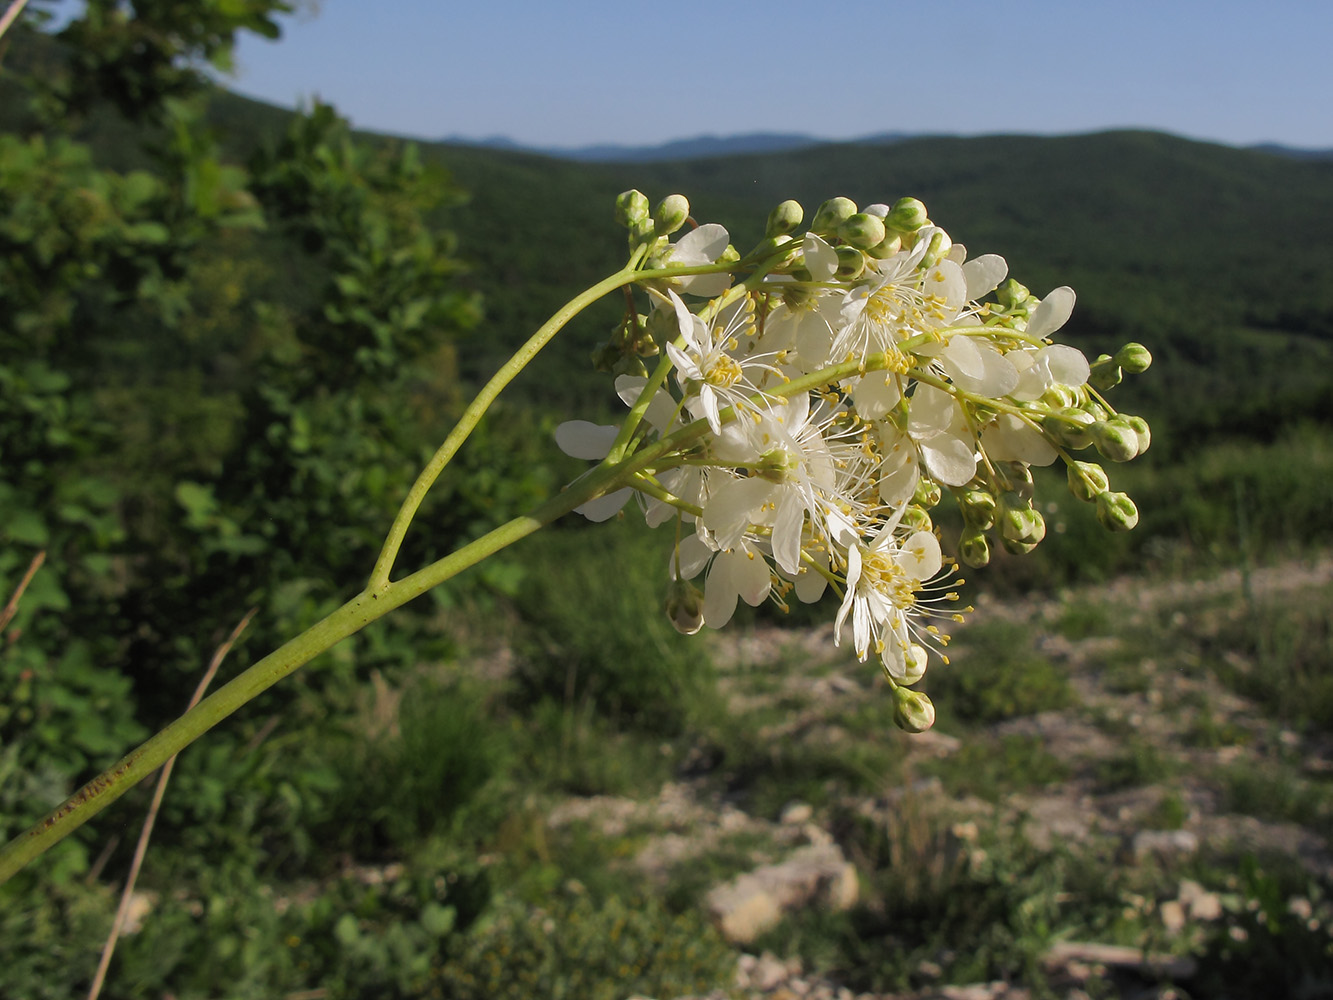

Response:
(557, 191), (1150, 731)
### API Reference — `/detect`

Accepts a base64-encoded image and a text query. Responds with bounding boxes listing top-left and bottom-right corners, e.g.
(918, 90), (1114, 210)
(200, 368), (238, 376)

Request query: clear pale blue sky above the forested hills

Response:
(229, 0), (1333, 148)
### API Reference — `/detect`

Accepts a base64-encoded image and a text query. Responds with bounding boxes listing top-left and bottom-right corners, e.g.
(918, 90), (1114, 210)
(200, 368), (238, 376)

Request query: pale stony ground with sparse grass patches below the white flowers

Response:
(549, 557), (1333, 1000)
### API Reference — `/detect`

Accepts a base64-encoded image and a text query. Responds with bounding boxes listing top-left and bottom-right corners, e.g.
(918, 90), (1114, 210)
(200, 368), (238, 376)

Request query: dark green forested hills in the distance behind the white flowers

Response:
(427, 132), (1333, 453)
